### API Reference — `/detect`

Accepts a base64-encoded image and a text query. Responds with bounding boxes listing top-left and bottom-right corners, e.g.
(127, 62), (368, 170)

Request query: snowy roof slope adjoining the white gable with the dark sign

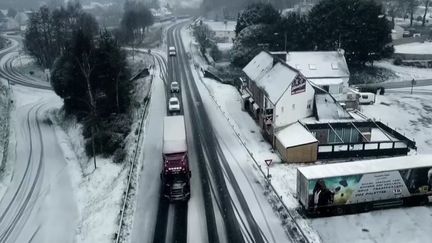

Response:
(256, 62), (299, 104)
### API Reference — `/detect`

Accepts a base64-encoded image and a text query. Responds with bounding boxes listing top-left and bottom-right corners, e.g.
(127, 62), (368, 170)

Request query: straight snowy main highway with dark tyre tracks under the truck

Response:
(131, 23), (290, 242)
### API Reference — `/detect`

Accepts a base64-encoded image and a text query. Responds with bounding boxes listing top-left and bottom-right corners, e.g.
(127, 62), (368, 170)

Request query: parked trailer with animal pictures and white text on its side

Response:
(297, 155), (432, 216)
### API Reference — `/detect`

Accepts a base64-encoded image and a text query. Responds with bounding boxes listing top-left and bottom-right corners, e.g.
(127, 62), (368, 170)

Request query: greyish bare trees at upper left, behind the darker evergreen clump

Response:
(24, 2), (98, 68)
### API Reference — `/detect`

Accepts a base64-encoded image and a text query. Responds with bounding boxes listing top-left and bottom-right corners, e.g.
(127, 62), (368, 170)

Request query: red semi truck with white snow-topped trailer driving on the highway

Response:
(161, 116), (191, 202)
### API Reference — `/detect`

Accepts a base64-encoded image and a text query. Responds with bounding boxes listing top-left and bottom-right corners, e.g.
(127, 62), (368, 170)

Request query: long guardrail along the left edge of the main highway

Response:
(114, 66), (154, 243)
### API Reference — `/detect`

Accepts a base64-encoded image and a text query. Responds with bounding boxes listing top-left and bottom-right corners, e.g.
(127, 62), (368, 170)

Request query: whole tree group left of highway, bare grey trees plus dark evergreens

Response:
(24, 3), (132, 161)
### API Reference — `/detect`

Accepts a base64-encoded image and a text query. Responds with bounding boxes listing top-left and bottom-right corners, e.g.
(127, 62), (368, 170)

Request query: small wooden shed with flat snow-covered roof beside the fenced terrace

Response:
(275, 122), (318, 163)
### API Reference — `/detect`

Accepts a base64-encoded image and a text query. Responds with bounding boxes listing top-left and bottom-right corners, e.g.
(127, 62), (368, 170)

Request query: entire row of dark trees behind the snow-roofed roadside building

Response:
(231, 0), (393, 67)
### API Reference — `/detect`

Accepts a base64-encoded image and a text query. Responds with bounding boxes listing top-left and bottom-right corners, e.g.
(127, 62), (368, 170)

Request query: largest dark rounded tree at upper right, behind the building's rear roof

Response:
(309, 0), (393, 65)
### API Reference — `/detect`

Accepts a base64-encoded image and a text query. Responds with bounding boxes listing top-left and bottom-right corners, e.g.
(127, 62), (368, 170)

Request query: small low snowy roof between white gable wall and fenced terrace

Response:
(315, 93), (352, 120)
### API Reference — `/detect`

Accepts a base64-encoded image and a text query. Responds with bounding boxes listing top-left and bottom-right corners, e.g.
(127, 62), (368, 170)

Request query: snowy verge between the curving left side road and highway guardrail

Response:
(51, 111), (126, 243)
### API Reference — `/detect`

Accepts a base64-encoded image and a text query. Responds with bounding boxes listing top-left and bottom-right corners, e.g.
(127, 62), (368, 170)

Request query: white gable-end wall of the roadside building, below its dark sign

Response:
(274, 82), (315, 129)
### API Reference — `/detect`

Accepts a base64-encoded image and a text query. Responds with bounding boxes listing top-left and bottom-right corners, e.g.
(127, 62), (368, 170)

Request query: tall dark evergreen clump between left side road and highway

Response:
(51, 30), (131, 159)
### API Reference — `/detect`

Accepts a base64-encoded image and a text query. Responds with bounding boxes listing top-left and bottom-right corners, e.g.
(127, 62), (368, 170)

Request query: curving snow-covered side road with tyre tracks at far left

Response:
(0, 35), (78, 242)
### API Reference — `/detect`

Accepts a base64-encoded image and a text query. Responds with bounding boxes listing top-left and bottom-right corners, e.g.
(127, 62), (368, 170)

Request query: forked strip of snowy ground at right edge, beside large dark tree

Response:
(374, 60), (432, 82)
